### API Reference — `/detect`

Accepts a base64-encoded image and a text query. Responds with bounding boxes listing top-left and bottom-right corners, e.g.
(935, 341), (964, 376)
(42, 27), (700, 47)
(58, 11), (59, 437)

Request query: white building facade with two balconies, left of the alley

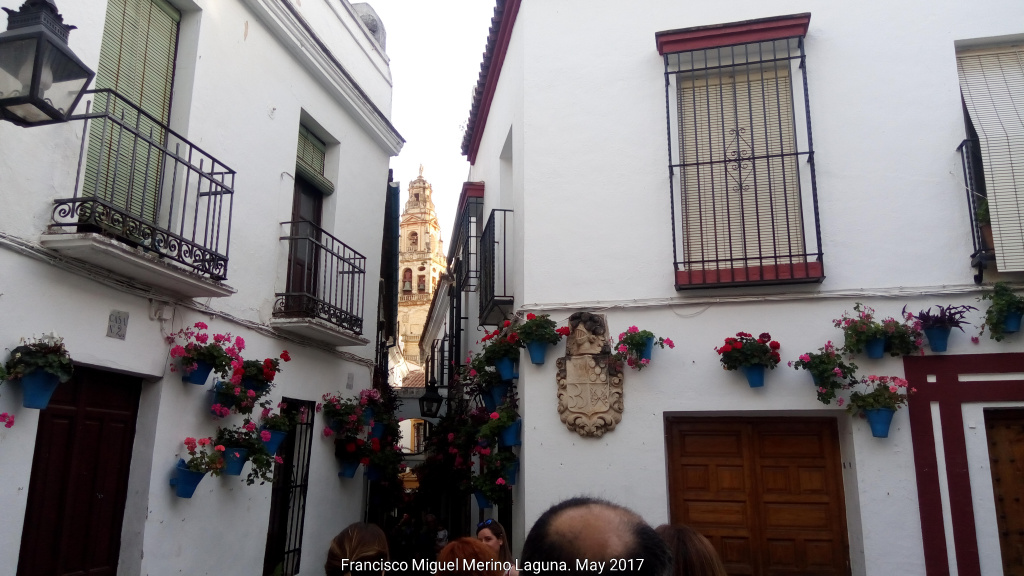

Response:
(0, 0), (403, 576)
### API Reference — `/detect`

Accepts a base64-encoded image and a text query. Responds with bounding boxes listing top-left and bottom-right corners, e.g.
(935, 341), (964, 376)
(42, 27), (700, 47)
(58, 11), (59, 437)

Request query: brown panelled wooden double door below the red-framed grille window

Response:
(667, 418), (849, 576)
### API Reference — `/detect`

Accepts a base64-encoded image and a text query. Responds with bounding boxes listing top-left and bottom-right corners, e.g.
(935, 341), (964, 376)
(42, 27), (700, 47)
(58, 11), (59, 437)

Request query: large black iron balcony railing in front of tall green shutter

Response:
(51, 89), (234, 280)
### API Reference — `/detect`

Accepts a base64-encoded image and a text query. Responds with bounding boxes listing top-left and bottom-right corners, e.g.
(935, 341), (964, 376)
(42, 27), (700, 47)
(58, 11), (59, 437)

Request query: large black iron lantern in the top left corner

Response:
(0, 0), (94, 126)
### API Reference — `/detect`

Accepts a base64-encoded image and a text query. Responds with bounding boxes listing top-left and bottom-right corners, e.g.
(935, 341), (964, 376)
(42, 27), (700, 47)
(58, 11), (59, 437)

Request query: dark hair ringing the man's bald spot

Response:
(522, 497), (672, 576)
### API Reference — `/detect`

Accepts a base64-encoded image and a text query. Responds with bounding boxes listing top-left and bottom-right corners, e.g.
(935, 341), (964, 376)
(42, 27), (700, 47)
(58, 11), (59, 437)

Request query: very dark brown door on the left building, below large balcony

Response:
(17, 367), (141, 576)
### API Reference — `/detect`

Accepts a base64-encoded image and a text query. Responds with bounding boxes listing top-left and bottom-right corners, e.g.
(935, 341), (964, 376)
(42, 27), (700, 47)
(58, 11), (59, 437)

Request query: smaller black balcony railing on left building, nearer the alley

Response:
(273, 220), (367, 334)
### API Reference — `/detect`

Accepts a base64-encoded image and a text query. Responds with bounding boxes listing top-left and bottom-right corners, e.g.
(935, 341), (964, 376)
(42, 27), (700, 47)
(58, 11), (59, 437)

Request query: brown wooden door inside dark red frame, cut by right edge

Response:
(985, 410), (1024, 576)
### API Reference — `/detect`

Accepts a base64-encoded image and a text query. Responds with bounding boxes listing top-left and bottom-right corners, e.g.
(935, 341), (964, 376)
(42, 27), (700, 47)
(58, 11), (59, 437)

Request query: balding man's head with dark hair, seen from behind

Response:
(522, 497), (672, 576)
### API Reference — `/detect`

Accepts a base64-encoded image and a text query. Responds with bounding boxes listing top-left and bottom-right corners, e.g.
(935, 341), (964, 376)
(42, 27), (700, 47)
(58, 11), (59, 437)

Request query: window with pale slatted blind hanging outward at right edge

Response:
(956, 46), (1024, 272)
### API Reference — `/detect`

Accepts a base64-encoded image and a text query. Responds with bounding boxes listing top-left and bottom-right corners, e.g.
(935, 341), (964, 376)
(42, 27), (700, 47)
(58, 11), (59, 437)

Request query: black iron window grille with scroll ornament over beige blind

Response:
(664, 31), (824, 290)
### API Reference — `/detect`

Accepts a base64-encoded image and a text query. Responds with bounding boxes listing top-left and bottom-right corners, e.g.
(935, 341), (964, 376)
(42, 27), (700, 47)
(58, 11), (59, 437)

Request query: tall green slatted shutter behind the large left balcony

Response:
(85, 0), (181, 222)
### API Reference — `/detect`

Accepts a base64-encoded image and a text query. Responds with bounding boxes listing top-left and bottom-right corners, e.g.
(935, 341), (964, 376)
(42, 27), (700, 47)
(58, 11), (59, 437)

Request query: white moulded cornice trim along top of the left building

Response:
(245, 0), (404, 156)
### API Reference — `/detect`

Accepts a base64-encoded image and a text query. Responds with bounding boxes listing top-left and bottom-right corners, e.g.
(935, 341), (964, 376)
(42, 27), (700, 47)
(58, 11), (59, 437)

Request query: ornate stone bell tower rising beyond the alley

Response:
(398, 164), (447, 364)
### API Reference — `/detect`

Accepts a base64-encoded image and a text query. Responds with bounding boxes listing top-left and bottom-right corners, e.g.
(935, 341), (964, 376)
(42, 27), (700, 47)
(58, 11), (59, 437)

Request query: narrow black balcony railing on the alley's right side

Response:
(479, 209), (513, 326)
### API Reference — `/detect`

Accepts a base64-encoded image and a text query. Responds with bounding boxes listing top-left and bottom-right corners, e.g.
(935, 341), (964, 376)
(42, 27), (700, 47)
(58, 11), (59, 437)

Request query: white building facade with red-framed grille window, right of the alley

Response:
(421, 0), (1024, 575)
